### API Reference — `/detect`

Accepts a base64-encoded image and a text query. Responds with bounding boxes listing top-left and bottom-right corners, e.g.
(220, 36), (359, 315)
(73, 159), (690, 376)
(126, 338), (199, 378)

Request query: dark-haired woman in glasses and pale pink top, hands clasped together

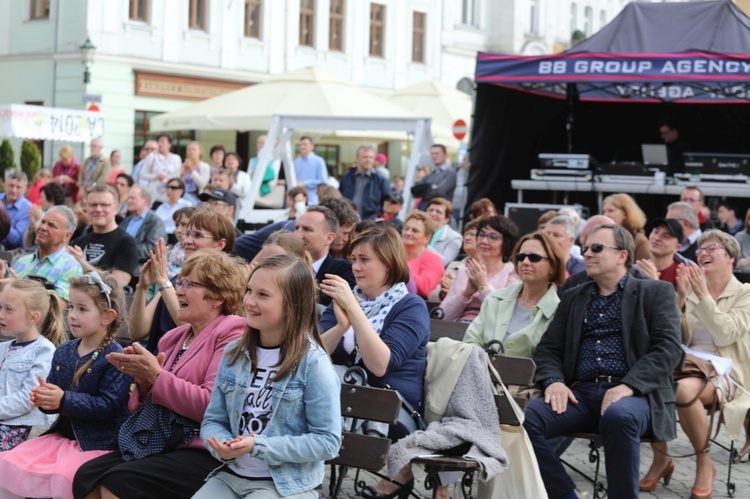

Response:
(440, 215), (520, 322)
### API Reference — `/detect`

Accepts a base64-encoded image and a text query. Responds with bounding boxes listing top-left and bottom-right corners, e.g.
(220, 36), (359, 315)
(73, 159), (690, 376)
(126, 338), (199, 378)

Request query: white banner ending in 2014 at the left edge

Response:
(0, 104), (104, 142)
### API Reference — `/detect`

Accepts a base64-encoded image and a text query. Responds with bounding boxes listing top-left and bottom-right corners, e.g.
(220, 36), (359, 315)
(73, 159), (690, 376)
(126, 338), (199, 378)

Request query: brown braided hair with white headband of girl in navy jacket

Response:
(69, 270), (125, 385)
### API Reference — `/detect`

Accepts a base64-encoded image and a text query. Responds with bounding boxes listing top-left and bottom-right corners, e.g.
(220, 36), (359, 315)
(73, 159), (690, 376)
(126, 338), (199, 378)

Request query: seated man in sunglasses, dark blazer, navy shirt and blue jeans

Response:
(524, 224), (683, 498)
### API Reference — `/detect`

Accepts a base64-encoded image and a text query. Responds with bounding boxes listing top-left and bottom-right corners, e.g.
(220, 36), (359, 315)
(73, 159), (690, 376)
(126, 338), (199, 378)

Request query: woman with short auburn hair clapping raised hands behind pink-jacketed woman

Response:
(128, 210), (237, 353)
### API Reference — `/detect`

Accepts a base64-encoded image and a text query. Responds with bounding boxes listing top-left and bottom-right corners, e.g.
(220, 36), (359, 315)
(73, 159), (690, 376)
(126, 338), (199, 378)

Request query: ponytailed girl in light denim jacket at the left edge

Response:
(0, 279), (63, 451)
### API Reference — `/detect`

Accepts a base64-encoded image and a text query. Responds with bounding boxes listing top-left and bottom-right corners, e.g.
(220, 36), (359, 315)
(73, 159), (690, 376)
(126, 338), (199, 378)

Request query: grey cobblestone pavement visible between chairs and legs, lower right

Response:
(323, 425), (750, 499)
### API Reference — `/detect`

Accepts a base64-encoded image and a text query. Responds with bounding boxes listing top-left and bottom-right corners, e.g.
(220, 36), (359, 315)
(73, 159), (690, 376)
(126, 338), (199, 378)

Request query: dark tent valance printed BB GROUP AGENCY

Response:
(476, 52), (750, 103)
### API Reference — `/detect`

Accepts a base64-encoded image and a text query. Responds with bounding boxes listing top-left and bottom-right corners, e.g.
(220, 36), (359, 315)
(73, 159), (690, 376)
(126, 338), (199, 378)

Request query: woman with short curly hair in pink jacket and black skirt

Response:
(73, 250), (248, 498)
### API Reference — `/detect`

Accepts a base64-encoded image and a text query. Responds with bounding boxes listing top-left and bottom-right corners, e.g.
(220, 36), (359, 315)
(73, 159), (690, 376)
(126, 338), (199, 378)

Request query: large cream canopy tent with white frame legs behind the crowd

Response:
(151, 68), (433, 218)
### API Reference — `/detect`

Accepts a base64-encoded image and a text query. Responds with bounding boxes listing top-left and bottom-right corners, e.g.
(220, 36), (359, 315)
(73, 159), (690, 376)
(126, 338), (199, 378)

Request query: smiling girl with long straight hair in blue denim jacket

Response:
(193, 255), (341, 499)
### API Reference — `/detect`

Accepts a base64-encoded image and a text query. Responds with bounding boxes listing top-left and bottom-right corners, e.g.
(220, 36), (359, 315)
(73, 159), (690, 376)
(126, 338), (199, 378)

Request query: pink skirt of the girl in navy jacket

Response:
(0, 433), (110, 499)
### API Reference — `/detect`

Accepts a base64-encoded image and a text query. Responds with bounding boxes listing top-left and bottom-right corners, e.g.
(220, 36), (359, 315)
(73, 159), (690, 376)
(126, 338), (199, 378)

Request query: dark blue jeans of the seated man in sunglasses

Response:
(524, 382), (651, 499)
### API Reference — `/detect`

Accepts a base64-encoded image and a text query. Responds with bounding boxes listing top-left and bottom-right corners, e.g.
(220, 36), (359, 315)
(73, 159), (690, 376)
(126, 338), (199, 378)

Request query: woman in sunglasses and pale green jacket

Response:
(464, 231), (565, 357)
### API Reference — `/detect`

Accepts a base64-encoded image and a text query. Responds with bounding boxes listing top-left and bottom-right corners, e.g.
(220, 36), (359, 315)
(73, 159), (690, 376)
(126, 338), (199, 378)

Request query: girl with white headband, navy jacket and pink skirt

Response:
(0, 272), (132, 498)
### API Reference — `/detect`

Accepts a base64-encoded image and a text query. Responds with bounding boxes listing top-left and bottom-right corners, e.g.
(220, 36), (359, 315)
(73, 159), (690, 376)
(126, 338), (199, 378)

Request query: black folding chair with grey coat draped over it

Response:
(412, 353), (536, 499)
